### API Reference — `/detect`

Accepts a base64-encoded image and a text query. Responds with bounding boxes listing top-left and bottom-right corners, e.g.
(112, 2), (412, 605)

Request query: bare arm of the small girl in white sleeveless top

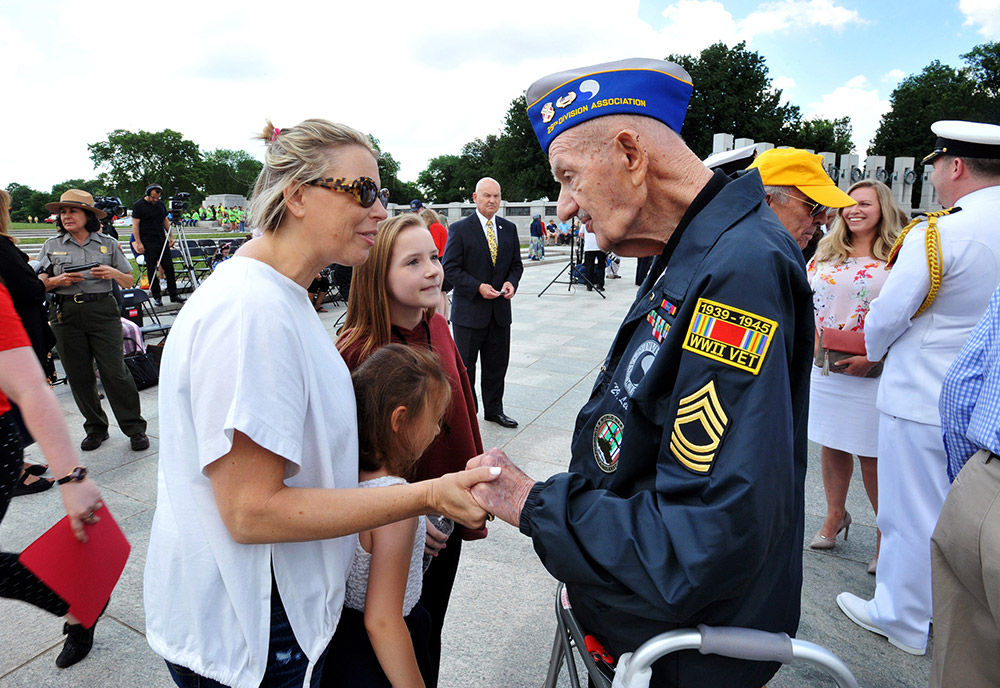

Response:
(365, 519), (424, 688)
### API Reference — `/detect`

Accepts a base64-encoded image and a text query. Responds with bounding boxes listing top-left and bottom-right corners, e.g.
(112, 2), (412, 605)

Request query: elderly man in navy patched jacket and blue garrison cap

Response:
(470, 59), (813, 688)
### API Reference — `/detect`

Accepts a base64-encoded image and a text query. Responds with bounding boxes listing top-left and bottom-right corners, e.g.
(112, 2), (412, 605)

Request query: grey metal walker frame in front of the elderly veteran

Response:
(543, 583), (859, 688)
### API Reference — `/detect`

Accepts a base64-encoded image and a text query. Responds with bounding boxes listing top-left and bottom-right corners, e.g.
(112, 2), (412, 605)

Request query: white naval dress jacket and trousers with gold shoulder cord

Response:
(865, 186), (1000, 648)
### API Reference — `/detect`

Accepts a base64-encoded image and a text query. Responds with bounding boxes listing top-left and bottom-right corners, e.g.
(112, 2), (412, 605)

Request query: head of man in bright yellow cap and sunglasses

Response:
(747, 148), (857, 251)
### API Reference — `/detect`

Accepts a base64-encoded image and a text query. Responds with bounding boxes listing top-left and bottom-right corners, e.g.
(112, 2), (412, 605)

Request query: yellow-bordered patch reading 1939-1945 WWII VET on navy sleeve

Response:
(684, 299), (778, 375)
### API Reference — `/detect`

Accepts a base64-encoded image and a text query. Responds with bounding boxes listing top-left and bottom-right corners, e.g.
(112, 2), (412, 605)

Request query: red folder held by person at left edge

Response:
(19, 506), (132, 628)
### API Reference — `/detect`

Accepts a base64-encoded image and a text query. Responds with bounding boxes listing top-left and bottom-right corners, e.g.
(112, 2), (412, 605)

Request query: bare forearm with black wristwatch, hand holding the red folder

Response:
(0, 346), (101, 542)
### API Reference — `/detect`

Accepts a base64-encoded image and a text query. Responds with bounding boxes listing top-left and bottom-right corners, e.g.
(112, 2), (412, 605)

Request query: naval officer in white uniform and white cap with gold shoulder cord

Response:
(837, 121), (1000, 655)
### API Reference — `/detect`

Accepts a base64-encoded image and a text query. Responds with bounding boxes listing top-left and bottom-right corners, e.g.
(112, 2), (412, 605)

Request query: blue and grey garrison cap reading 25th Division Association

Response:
(526, 57), (694, 153)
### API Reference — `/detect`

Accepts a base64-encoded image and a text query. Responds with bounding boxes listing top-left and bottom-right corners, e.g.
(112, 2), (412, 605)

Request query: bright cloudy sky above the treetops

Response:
(0, 0), (1000, 190)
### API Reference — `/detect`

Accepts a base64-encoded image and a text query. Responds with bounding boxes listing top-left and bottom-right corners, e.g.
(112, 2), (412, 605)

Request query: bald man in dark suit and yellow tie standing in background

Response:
(444, 177), (524, 428)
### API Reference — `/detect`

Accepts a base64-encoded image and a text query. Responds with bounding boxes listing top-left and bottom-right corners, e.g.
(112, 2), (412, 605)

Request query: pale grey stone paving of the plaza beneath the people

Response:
(0, 254), (933, 688)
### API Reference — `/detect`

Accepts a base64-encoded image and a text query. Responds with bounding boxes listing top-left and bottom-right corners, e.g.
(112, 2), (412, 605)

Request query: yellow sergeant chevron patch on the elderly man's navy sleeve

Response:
(670, 379), (729, 475)
